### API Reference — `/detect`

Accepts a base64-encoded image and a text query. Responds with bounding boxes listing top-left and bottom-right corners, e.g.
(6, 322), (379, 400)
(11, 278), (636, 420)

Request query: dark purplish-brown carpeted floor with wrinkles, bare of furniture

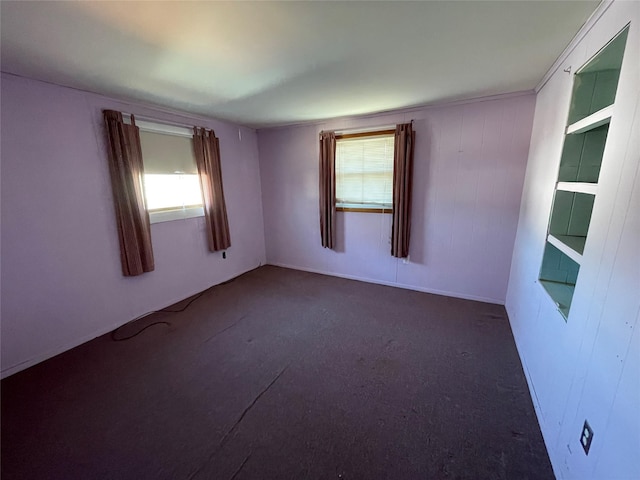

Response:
(1, 266), (553, 480)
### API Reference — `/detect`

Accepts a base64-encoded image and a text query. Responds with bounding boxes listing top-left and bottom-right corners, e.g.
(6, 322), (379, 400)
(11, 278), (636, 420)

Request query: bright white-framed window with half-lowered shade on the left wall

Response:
(136, 121), (204, 223)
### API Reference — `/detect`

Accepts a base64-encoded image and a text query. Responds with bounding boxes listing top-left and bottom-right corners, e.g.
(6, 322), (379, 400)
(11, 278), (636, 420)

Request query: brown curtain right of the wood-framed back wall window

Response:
(391, 123), (416, 258)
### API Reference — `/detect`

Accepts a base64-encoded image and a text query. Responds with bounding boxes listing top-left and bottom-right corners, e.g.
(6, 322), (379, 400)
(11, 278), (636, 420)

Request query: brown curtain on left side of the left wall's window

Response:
(103, 110), (155, 277)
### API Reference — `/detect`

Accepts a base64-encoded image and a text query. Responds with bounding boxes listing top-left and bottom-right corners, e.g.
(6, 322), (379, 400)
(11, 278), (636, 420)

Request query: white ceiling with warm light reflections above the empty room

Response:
(0, 0), (599, 127)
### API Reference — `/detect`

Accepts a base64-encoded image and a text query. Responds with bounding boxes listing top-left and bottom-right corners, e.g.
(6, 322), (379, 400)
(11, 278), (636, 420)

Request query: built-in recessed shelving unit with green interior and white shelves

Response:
(539, 27), (628, 319)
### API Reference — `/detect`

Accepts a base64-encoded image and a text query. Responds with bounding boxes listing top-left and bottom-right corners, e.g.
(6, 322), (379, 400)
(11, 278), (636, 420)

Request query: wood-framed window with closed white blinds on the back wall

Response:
(336, 130), (395, 213)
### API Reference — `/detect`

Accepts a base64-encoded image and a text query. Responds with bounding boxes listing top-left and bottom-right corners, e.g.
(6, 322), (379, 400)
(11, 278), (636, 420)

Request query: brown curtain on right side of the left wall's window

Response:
(193, 127), (231, 252)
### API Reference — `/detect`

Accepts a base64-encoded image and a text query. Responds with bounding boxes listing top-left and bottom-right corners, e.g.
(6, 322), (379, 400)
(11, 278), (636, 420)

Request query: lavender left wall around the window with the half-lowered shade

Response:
(1, 74), (265, 376)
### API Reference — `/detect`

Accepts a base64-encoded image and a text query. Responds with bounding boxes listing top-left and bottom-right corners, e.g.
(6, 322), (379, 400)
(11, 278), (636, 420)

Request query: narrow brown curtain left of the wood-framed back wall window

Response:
(320, 132), (336, 249)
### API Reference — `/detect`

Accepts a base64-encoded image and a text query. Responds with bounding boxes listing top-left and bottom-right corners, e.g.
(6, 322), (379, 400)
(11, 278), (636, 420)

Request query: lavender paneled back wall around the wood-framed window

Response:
(258, 94), (535, 303)
